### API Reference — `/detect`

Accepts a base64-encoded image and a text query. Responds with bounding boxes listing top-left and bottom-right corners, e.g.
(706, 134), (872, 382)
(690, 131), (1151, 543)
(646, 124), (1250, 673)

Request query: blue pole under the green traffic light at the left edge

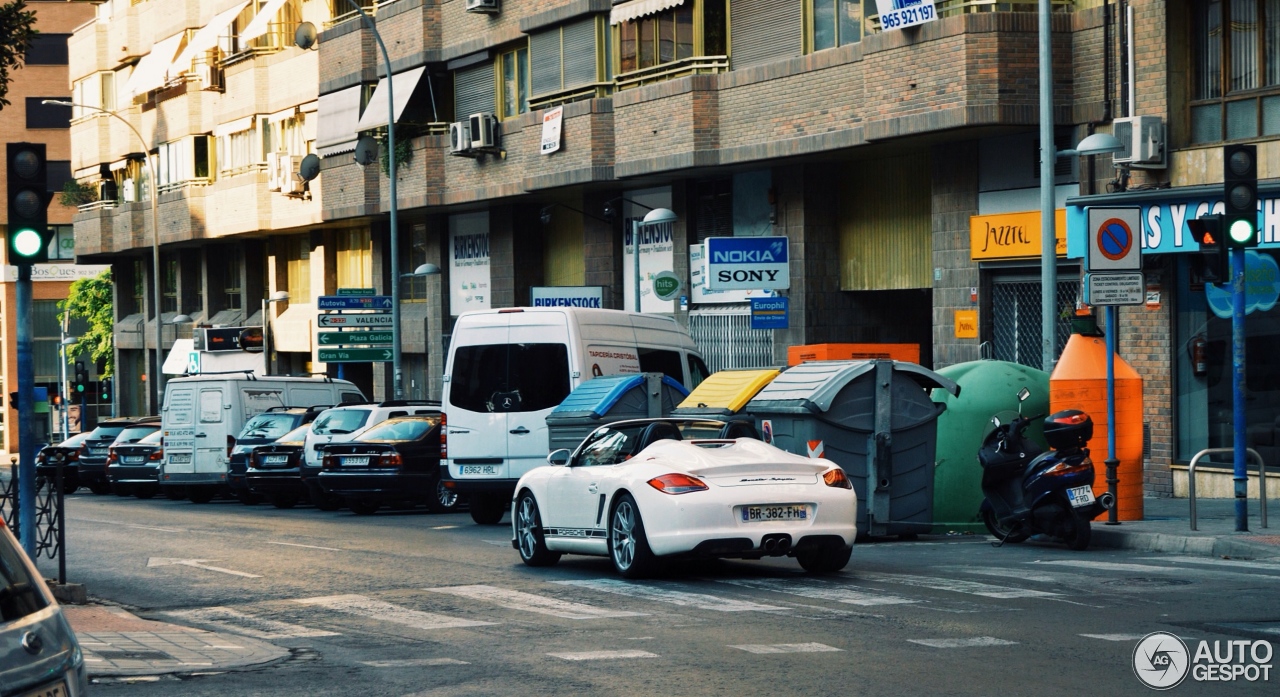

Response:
(14, 263), (38, 559)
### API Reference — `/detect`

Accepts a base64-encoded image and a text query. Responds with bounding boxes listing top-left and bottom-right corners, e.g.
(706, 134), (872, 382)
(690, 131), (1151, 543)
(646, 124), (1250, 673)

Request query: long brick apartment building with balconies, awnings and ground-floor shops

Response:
(72, 0), (1280, 501)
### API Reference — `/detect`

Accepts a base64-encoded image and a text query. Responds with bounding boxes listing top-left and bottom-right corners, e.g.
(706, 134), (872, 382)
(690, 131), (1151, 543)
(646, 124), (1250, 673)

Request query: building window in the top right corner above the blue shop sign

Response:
(1190, 0), (1280, 143)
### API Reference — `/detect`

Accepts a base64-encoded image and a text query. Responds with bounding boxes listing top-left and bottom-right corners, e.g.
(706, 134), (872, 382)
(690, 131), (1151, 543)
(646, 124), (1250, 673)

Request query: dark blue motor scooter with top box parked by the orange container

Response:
(978, 388), (1115, 550)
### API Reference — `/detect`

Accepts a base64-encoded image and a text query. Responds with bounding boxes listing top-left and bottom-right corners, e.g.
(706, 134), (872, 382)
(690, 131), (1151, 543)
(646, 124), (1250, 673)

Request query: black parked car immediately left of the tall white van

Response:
(320, 413), (458, 515)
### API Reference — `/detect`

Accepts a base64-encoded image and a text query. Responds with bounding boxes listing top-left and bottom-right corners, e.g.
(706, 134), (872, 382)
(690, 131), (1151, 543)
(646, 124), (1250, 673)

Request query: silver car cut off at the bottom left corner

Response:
(0, 519), (88, 697)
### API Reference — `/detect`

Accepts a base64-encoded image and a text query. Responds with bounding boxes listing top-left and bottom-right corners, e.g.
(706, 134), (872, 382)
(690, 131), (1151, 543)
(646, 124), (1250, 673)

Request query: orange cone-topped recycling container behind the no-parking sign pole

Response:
(1048, 334), (1143, 521)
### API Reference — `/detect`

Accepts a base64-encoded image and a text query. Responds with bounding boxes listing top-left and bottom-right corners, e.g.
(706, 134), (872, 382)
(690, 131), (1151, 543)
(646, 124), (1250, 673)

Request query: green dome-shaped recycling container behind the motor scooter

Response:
(932, 361), (1048, 535)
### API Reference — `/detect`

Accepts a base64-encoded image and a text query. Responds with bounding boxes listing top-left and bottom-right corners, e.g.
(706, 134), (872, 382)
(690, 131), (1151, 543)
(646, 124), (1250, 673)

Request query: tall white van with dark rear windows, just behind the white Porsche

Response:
(440, 307), (708, 524)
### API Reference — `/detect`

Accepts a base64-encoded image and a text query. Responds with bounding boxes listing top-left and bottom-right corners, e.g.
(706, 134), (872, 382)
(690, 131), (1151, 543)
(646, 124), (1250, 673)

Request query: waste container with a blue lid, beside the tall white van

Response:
(547, 372), (689, 453)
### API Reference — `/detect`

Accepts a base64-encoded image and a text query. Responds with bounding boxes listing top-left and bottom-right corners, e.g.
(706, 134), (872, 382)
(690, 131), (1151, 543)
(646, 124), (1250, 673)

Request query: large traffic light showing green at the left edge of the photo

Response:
(6, 143), (52, 265)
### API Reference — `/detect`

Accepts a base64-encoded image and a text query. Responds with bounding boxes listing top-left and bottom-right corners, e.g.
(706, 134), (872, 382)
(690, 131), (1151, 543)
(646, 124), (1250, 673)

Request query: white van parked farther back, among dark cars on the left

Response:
(160, 372), (365, 503)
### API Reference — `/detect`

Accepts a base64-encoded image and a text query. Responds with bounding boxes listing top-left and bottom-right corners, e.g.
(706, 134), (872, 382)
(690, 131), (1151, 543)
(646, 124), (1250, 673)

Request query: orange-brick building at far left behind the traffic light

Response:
(0, 1), (95, 451)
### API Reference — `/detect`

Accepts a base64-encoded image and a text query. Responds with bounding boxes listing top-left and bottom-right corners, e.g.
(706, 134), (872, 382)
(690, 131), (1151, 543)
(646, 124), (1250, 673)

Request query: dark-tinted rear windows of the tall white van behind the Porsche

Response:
(449, 344), (570, 412)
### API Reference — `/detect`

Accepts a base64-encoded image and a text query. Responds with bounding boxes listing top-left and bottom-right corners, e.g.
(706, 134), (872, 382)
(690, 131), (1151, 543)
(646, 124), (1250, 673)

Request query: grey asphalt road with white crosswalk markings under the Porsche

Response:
(41, 495), (1280, 697)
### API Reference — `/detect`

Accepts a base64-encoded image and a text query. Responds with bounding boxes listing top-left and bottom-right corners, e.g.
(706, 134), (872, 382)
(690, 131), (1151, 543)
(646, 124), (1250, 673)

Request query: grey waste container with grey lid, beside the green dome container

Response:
(746, 361), (959, 537)
